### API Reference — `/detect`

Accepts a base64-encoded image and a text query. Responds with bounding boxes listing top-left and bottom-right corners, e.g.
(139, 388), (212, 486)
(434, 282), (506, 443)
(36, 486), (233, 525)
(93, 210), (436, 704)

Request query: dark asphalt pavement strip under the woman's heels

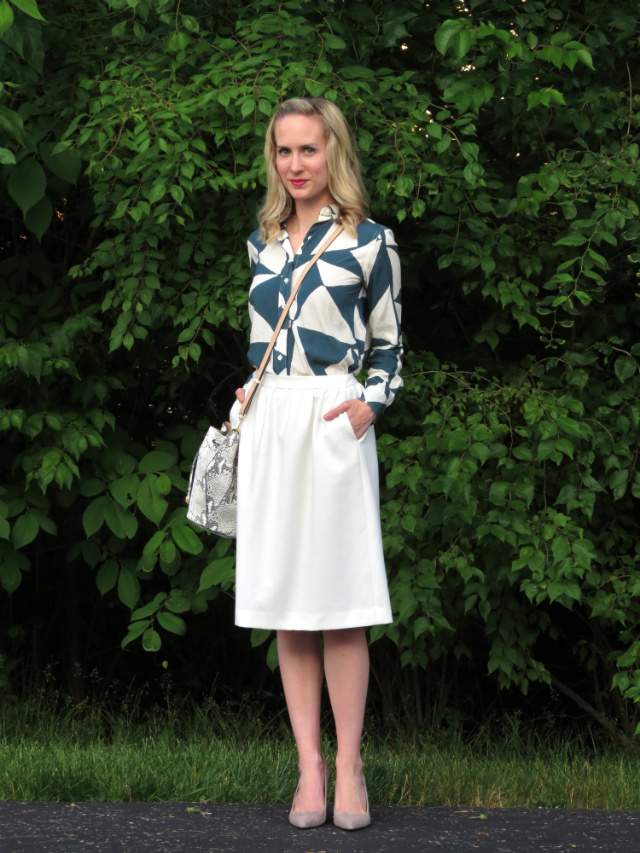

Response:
(0, 802), (640, 853)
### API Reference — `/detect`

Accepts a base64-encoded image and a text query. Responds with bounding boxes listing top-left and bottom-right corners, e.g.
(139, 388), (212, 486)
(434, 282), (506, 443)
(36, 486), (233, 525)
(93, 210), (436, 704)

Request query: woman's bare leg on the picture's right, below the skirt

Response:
(324, 628), (369, 813)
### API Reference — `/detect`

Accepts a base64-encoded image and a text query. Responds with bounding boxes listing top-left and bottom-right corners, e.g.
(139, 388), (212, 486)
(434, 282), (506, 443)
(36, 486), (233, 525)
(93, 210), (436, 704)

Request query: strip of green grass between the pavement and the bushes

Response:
(0, 692), (640, 809)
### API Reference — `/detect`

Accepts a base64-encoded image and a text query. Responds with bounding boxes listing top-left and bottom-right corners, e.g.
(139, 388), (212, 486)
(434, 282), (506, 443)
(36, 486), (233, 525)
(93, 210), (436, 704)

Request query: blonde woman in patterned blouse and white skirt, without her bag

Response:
(232, 98), (402, 829)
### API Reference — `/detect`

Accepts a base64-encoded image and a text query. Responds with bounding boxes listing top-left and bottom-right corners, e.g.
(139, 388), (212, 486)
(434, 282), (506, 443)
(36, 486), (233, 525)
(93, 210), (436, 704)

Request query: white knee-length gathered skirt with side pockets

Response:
(232, 374), (392, 631)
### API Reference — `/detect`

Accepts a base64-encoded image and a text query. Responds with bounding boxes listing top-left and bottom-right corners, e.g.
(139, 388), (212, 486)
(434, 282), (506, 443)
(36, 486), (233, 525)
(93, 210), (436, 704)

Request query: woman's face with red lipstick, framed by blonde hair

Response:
(274, 115), (333, 209)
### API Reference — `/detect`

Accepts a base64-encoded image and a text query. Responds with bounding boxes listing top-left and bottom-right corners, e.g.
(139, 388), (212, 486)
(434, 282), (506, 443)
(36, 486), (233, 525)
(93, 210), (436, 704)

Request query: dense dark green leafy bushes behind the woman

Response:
(0, 0), (640, 742)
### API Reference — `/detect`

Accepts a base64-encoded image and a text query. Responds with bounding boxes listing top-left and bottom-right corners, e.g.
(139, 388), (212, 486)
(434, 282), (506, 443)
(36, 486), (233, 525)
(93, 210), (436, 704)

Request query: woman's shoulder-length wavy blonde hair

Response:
(258, 98), (369, 243)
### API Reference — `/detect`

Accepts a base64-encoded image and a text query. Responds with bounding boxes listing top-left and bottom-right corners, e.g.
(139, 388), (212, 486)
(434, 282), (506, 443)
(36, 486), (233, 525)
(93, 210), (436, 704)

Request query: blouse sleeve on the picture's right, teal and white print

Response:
(364, 228), (402, 418)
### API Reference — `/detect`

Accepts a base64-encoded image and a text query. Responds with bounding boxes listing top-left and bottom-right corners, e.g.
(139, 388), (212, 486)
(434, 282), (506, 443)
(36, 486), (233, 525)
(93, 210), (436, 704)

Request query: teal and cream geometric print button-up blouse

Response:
(248, 206), (402, 417)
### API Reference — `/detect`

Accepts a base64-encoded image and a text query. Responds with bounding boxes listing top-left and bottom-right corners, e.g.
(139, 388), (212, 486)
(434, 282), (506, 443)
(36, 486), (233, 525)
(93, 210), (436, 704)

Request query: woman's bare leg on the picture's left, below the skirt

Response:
(278, 631), (324, 812)
